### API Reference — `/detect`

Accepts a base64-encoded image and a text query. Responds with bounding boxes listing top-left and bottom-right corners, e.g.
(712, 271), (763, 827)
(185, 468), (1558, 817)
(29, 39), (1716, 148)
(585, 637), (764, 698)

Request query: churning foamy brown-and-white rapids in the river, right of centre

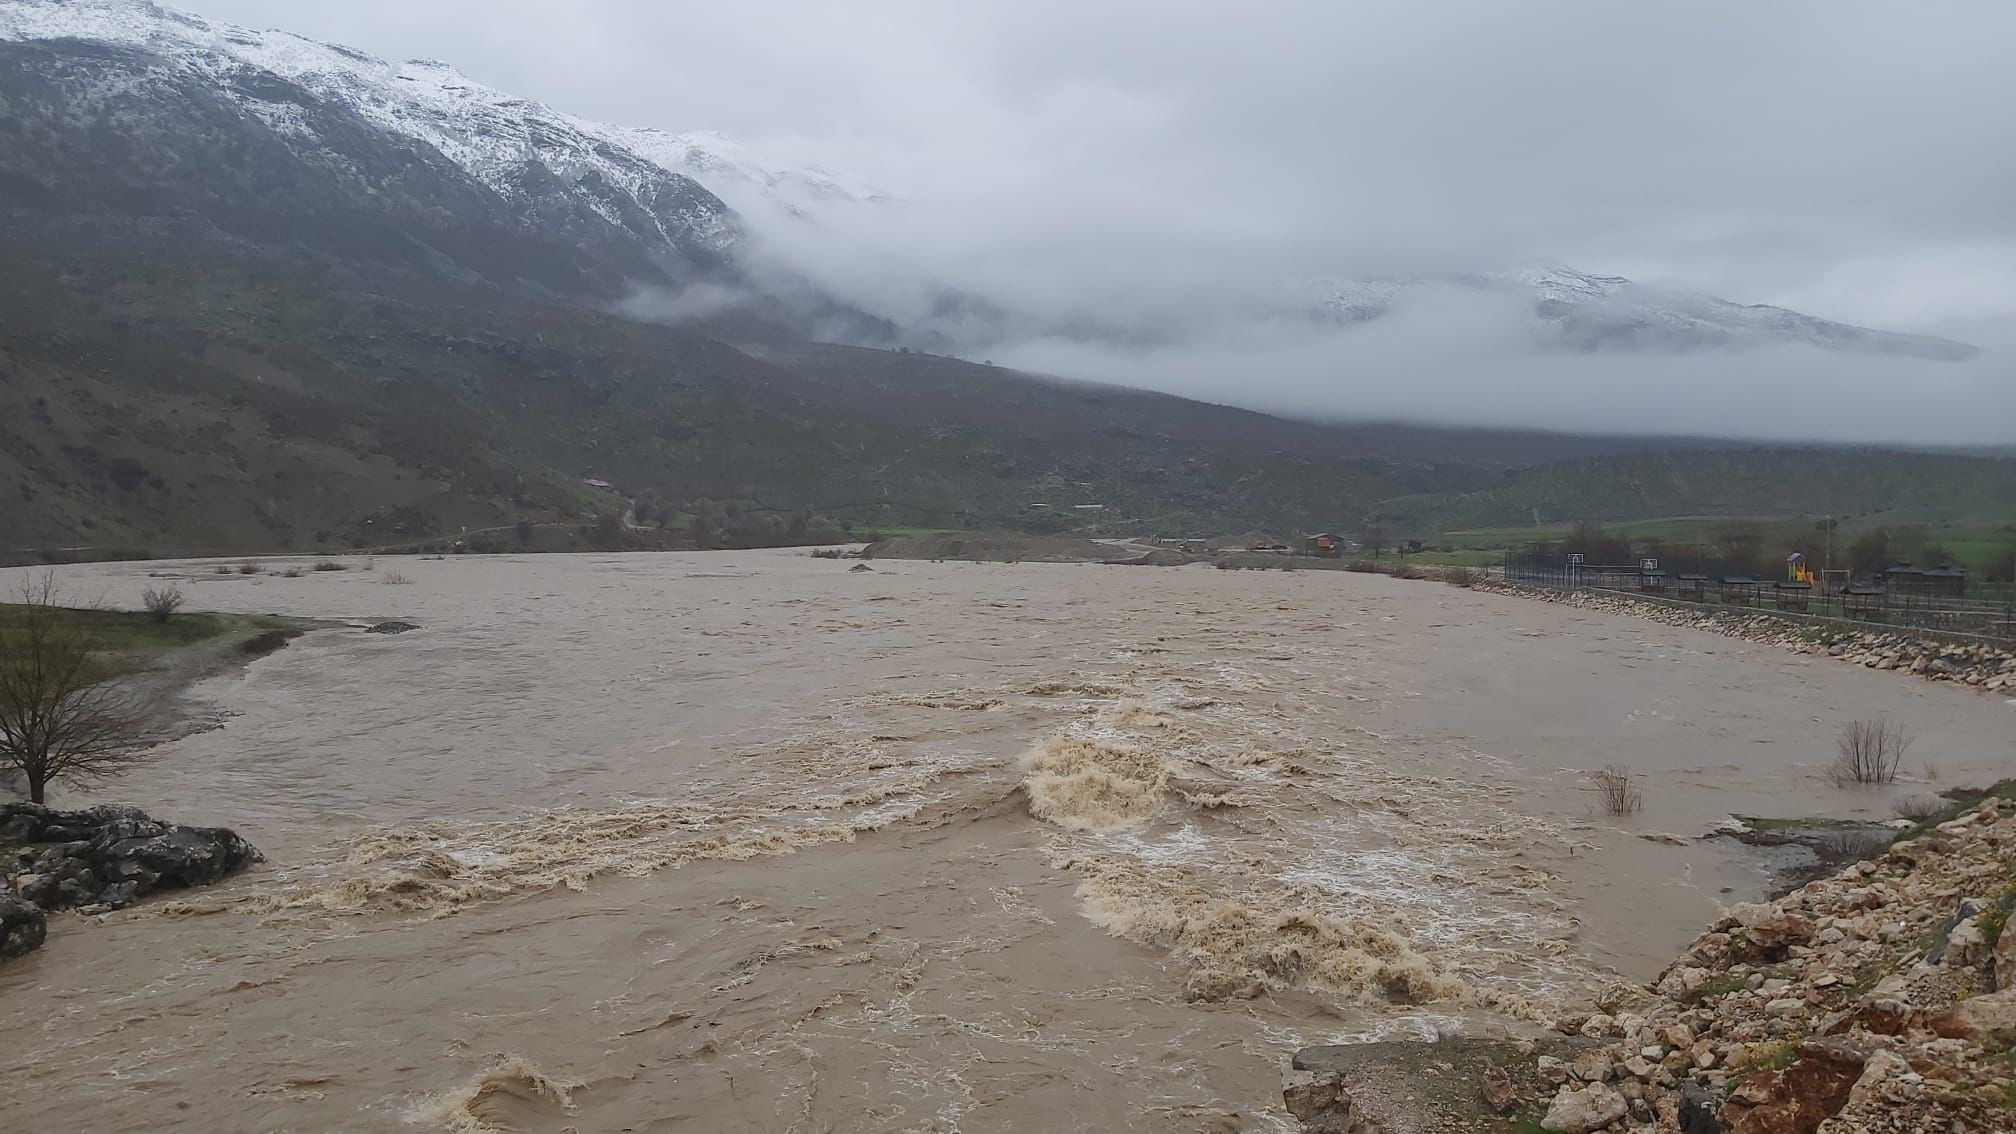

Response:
(1022, 672), (1587, 1019)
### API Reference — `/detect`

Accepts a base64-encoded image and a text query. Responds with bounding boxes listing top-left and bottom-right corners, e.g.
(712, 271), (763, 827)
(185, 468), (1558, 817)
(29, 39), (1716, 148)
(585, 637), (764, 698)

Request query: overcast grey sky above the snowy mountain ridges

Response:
(181, 0), (2016, 333)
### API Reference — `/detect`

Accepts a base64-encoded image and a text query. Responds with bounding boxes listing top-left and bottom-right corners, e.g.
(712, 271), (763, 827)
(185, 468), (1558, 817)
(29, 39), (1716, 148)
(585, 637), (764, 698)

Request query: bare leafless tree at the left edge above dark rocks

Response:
(0, 573), (153, 803)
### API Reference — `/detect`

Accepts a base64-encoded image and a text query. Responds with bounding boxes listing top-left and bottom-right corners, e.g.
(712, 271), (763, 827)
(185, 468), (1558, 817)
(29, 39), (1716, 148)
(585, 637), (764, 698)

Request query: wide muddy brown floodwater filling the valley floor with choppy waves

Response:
(0, 551), (2016, 1132)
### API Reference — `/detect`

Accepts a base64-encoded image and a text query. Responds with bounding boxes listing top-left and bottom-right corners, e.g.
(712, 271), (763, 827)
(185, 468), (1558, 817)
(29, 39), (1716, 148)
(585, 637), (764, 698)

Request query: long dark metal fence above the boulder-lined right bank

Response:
(1504, 551), (2016, 642)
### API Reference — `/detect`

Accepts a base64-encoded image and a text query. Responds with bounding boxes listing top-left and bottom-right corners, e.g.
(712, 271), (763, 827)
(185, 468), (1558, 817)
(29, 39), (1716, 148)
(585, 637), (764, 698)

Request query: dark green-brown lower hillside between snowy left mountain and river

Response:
(0, 240), (1419, 551)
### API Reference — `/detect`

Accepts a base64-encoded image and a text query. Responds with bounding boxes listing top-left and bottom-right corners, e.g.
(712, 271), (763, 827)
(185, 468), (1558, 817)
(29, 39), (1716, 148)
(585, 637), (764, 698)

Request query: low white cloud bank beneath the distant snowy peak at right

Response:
(994, 293), (2016, 444)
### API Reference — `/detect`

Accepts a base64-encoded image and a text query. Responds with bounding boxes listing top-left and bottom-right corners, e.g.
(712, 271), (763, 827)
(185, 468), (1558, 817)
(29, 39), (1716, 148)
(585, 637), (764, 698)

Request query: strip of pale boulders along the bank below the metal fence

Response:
(1474, 575), (2016, 692)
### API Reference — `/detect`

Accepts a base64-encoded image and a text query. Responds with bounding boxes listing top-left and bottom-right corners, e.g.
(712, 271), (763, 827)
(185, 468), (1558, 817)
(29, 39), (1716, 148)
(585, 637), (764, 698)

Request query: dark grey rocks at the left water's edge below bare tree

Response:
(0, 803), (264, 958)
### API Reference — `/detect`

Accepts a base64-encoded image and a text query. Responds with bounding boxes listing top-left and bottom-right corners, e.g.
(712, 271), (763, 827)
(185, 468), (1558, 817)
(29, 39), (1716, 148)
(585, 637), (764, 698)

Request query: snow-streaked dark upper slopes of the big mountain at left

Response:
(0, 0), (889, 330)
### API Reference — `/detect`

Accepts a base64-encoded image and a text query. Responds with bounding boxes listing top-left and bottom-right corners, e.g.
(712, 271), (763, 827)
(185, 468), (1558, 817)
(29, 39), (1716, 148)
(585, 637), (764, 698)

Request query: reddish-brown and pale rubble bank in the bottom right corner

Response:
(1288, 785), (2016, 1134)
